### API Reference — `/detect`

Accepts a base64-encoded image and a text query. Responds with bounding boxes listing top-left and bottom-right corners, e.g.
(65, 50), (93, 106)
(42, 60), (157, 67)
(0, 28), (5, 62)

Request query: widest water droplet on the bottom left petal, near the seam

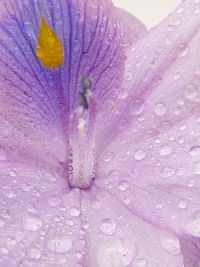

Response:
(47, 234), (72, 254)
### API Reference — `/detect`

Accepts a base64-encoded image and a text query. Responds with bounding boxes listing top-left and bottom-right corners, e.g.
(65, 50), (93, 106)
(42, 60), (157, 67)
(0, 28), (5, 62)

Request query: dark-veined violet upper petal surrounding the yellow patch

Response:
(0, 0), (124, 168)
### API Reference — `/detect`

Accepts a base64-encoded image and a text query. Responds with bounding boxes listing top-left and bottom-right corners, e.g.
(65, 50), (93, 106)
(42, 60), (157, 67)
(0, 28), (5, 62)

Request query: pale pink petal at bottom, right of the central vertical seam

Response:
(82, 188), (183, 267)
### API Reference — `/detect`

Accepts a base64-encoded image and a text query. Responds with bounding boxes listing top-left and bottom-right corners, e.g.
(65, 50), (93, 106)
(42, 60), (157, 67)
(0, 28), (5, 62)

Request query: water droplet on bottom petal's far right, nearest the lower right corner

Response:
(160, 236), (181, 255)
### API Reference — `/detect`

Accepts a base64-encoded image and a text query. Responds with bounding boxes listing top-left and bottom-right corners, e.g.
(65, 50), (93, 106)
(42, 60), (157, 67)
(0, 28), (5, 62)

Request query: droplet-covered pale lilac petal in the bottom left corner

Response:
(0, 161), (84, 267)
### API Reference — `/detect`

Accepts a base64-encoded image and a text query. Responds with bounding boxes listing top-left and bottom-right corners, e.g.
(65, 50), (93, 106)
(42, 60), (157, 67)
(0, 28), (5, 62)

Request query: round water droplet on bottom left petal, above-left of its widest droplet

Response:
(23, 213), (42, 232)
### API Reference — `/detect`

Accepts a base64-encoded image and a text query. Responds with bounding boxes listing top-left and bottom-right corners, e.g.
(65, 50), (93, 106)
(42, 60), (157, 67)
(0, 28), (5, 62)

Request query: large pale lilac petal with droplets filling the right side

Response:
(96, 1), (200, 262)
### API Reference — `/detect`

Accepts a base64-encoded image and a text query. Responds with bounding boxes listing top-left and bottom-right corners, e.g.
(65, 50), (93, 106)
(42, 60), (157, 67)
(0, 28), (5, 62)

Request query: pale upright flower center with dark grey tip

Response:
(67, 77), (96, 189)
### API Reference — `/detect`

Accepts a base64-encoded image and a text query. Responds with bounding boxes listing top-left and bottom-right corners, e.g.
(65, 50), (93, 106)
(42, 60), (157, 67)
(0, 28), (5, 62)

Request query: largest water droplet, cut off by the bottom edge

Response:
(96, 238), (138, 267)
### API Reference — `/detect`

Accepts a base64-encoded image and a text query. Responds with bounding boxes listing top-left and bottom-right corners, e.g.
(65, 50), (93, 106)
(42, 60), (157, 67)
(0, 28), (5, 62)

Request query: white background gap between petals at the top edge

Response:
(113, 0), (181, 28)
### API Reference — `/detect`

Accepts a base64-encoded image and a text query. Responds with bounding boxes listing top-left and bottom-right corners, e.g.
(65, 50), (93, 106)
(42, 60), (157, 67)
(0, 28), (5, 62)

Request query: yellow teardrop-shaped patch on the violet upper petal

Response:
(36, 17), (64, 68)
